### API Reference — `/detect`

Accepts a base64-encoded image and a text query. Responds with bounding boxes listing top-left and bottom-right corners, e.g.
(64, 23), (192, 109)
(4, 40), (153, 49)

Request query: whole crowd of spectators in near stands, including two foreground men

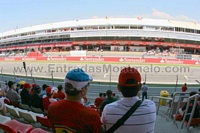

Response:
(0, 67), (200, 133)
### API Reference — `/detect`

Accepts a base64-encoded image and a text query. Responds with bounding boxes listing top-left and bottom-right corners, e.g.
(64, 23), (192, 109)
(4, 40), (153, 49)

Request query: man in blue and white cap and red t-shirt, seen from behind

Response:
(48, 68), (101, 133)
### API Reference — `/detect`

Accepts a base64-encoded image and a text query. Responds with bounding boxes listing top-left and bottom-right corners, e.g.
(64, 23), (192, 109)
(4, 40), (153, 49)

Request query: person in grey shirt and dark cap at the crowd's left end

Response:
(6, 81), (21, 103)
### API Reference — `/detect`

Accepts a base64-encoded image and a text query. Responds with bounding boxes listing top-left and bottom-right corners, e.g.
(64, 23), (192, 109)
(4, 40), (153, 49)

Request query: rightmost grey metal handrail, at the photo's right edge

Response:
(181, 94), (200, 130)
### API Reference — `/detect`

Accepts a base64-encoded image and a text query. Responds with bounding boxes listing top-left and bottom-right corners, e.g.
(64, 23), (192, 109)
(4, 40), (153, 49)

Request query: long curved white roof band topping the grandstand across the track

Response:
(0, 18), (200, 37)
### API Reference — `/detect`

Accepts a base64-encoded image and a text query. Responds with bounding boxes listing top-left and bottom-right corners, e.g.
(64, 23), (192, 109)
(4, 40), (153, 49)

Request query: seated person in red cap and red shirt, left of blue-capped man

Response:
(42, 86), (57, 110)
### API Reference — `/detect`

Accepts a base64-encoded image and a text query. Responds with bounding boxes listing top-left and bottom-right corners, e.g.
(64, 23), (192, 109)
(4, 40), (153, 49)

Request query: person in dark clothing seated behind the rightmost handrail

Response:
(179, 91), (200, 122)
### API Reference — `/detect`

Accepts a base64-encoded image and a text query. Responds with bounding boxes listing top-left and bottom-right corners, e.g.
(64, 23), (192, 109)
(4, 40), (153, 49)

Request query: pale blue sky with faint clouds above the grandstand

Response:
(0, 0), (200, 33)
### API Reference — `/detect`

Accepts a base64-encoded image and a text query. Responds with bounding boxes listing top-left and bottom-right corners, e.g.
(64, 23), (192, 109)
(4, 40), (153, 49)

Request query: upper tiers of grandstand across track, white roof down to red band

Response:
(0, 17), (200, 51)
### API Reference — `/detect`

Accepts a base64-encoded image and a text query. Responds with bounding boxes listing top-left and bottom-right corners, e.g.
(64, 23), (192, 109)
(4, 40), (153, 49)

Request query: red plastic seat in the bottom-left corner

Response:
(0, 120), (33, 133)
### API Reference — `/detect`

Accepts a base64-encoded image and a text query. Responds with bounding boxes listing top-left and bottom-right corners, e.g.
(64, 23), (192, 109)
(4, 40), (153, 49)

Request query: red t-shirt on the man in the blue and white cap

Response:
(47, 100), (101, 133)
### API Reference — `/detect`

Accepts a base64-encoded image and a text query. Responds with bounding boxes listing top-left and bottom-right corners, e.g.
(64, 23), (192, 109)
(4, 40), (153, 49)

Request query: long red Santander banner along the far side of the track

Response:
(0, 56), (200, 65)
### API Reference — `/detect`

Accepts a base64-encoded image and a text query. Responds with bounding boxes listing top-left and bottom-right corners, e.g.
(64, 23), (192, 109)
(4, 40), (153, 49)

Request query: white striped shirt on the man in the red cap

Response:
(101, 97), (156, 133)
